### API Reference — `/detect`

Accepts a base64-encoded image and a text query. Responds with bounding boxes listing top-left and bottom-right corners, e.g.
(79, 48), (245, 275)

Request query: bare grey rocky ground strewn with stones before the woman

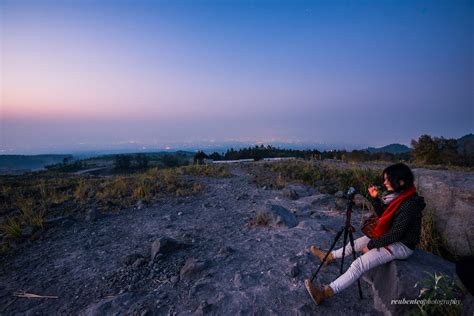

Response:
(0, 166), (379, 315)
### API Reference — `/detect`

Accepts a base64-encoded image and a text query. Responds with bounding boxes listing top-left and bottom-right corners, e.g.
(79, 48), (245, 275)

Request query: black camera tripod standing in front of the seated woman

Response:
(311, 187), (362, 299)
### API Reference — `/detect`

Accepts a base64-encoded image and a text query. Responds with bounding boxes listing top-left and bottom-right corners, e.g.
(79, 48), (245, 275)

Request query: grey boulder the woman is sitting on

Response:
(362, 249), (455, 315)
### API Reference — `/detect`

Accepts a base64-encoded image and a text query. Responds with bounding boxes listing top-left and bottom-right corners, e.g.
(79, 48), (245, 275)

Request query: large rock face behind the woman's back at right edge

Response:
(413, 169), (474, 256)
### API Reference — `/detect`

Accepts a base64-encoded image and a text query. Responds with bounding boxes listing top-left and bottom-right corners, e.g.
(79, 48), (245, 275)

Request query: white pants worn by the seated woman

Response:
(329, 236), (413, 293)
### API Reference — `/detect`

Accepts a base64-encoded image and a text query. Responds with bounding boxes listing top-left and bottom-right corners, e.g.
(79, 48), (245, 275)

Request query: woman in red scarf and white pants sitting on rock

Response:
(305, 163), (426, 304)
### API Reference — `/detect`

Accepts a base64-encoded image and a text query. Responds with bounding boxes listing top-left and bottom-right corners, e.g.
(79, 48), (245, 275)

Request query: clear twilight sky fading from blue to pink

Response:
(0, 0), (474, 154)
